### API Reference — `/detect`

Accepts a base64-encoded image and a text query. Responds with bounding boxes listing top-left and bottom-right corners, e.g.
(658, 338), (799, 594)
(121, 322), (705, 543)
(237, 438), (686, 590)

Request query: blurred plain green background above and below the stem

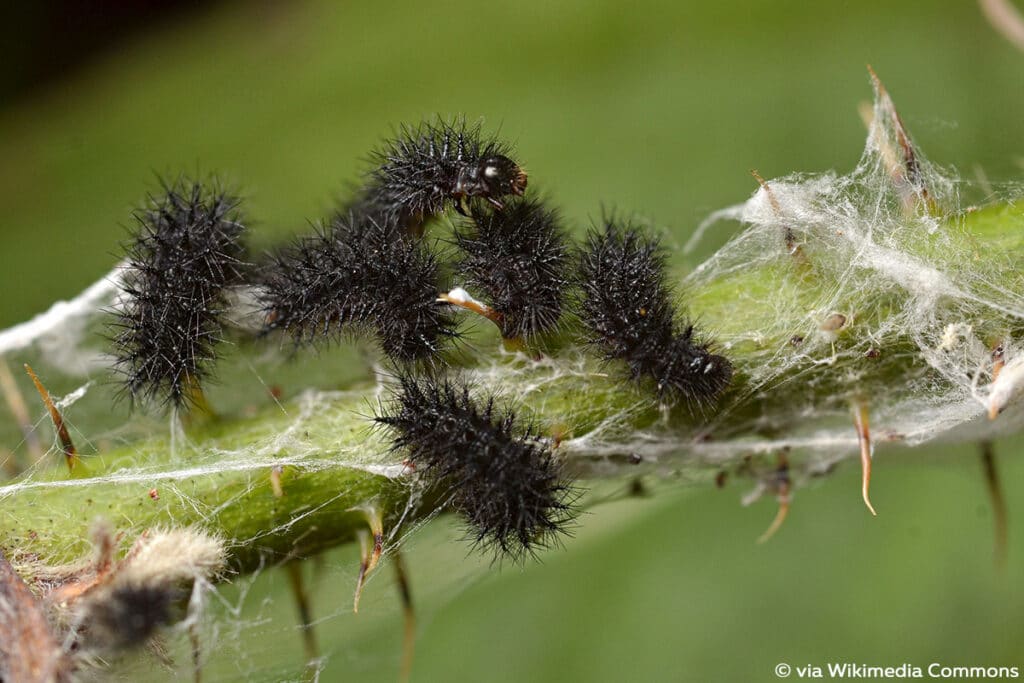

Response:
(0, 0), (1024, 682)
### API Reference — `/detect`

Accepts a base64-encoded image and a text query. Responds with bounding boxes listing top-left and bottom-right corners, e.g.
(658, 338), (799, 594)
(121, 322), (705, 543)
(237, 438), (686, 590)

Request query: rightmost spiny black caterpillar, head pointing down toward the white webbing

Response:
(579, 219), (732, 404)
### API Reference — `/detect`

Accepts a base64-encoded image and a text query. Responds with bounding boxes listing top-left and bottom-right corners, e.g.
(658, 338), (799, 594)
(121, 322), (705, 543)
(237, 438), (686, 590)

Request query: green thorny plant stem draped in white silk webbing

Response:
(0, 201), (1024, 574)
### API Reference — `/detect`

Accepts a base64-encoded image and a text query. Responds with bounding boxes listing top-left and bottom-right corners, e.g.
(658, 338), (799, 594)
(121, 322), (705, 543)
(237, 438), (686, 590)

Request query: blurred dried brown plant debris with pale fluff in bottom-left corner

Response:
(0, 525), (225, 682)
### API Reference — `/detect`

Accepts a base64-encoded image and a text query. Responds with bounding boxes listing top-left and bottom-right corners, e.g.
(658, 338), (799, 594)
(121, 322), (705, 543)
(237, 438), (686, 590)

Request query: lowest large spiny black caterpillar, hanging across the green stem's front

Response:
(377, 376), (575, 560)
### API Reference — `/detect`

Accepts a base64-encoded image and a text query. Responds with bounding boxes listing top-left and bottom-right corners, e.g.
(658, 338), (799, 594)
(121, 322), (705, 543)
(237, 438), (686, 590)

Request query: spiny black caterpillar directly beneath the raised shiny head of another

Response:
(455, 200), (570, 339)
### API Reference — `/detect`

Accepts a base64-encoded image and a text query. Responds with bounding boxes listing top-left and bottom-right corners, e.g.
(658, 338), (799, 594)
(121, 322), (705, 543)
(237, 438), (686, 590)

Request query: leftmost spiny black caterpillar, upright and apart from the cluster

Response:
(113, 179), (245, 408)
